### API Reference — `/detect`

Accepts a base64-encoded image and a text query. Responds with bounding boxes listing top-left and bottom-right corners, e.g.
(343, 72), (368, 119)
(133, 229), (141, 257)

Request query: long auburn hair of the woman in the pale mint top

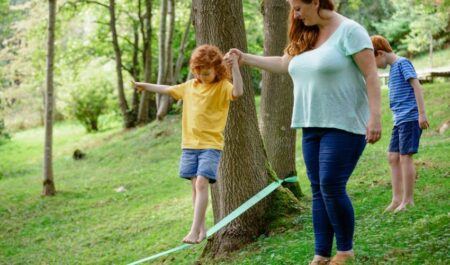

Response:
(285, 0), (335, 56)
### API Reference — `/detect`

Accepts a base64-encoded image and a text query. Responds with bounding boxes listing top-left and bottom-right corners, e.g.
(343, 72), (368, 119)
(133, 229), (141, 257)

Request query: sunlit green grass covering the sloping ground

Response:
(0, 83), (450, 265)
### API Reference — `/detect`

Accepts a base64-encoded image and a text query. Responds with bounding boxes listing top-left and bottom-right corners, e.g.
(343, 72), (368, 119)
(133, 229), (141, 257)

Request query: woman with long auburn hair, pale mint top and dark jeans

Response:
(227, 0), (381, 265)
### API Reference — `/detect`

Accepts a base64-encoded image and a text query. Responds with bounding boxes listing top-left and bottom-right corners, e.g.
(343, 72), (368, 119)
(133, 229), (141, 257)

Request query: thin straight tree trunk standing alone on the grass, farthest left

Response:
(42, 0), (56, 196)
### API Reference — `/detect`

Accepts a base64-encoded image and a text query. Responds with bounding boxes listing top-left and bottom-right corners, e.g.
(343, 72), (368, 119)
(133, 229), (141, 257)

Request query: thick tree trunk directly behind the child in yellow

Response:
(193, 0), (300, 257)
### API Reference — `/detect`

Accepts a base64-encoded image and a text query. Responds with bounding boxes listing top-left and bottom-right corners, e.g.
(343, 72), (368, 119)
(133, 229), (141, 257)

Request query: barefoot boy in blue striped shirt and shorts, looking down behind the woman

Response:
(371, 35), (429, 212)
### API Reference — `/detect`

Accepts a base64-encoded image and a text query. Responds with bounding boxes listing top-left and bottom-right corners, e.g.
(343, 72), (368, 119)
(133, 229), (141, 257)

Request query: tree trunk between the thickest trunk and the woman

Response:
(261, 0), (301, 197)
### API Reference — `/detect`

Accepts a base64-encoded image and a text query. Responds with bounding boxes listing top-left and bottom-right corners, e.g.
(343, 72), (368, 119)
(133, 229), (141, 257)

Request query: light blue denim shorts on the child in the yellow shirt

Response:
(180, 149), (222, 183)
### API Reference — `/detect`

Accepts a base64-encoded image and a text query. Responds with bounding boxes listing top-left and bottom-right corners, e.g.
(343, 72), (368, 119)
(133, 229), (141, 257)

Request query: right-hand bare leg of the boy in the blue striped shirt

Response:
(395, 155), (416, 212)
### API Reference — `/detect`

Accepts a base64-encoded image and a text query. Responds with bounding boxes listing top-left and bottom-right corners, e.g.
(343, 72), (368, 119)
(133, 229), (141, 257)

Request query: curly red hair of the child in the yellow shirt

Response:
(189, 44), (230, 82)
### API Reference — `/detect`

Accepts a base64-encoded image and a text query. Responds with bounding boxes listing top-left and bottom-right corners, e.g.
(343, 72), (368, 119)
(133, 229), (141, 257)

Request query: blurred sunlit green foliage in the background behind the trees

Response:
(0, 0), (450, 130)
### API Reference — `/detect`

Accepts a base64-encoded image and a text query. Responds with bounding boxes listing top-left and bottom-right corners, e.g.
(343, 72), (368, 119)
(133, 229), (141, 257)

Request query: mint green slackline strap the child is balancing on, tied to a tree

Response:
(128, 176), (297, 265)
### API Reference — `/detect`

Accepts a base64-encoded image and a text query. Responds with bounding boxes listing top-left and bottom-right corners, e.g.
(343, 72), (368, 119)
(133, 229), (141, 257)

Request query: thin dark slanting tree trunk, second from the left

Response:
(108, 0), (135, 128)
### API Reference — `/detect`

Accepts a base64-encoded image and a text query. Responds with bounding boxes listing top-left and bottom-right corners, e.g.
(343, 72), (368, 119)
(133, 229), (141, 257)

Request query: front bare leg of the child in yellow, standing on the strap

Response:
(183, 176), (209, 244)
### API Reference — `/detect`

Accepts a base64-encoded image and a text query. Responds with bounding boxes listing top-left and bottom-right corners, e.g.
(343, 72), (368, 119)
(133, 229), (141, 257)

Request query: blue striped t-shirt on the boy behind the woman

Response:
(388, 57), (419, 125)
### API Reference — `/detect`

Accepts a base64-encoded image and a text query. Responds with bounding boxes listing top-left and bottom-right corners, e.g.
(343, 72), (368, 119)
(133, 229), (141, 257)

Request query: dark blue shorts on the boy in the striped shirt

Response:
(389, 121), (422, 155)
